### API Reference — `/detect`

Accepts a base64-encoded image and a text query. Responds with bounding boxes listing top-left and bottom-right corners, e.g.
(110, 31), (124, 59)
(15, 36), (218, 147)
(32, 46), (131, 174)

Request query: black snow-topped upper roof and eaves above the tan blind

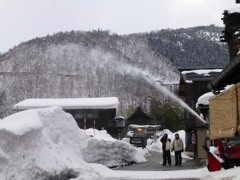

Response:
(210, 8), (240, 90)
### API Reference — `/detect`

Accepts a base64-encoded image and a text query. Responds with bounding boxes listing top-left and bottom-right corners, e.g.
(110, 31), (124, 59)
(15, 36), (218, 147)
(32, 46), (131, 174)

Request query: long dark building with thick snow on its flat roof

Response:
(14, 97), (119, 135)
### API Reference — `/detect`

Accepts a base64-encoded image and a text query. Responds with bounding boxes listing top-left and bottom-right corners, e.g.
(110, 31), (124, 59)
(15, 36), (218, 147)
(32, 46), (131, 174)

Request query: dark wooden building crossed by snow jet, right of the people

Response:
(179, 69), (222, 158)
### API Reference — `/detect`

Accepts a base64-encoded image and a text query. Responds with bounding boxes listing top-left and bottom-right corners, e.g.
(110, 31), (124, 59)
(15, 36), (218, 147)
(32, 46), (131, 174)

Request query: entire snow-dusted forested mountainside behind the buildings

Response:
(0, 27), (227, 117)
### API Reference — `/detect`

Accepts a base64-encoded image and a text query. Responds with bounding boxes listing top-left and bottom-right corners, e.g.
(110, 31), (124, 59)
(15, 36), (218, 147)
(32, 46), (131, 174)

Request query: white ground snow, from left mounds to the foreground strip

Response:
(0, 107), (240, 180)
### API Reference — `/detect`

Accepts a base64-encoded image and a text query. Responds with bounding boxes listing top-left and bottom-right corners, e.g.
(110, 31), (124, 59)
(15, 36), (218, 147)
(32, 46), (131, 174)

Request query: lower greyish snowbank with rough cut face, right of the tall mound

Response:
(83, 129), (146, 167)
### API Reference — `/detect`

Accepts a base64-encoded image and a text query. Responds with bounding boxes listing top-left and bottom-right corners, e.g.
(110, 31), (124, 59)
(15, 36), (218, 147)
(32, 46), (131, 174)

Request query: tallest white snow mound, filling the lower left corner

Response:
(0, 108), (95, 180)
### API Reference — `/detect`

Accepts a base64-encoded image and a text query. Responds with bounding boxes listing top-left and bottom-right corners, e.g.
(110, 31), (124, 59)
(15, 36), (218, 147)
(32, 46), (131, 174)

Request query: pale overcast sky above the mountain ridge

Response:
(0, 0), (236, 52)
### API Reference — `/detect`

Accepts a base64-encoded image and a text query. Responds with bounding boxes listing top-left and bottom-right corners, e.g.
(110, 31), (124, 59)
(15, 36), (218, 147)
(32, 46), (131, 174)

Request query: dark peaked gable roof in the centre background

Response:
(125, 106), (159, 125)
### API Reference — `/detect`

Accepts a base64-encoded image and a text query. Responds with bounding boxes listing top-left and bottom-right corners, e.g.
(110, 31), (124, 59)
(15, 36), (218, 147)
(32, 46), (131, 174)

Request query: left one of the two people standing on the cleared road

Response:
(161, 134), (172, 166)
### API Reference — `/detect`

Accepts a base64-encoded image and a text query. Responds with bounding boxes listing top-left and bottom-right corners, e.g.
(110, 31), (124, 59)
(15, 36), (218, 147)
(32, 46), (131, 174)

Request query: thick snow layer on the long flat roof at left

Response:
(14, 97), (119, 109)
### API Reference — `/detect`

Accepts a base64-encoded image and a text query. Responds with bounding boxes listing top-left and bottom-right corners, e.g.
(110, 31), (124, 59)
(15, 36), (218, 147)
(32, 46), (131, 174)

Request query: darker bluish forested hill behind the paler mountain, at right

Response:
(147, 25), (229, 69)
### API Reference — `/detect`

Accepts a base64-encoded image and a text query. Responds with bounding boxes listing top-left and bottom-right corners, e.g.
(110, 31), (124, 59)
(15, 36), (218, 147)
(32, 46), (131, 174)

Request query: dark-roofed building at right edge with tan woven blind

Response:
(209, 8), (240, 142)
